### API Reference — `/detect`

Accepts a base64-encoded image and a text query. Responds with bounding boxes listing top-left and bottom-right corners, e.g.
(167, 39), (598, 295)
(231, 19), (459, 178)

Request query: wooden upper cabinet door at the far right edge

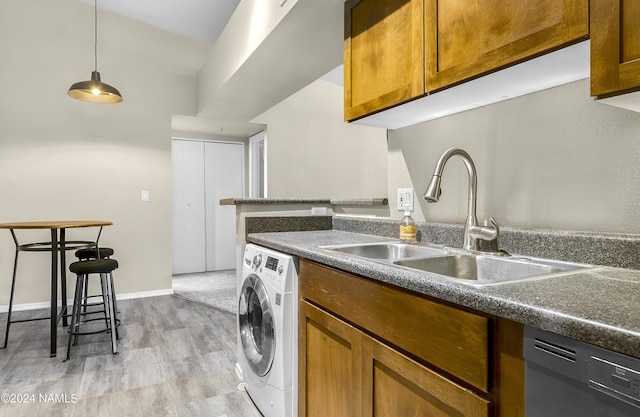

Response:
(591, 0), (640, 98)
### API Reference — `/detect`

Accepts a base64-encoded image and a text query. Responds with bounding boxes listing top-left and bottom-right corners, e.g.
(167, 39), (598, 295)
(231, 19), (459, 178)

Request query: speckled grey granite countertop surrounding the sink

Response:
(247, 230), (640, 358)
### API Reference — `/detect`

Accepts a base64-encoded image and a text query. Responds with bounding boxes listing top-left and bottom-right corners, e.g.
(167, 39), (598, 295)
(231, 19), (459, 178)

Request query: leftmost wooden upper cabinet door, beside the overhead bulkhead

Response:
(344, 0), (425, 120)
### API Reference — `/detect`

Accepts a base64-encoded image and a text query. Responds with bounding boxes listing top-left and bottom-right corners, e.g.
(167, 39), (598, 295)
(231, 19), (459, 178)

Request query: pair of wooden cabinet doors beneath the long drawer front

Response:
(299, 301), (490, 417)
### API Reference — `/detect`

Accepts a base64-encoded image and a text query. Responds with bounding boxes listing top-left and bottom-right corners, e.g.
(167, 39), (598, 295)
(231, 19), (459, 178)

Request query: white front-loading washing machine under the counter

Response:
(238, 244), (298, 417)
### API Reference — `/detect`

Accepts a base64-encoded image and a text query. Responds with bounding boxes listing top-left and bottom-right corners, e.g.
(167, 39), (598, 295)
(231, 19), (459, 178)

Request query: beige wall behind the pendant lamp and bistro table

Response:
(0, 0), (209, 306)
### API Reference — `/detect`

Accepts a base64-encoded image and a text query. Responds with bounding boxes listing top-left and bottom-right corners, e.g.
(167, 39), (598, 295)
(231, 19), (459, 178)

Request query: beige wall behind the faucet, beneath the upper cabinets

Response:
(389, 80), (640, 234)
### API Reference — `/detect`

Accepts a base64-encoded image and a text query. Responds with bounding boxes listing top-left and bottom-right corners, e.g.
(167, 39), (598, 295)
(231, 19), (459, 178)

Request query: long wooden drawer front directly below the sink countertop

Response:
(299, 260), (490, 392)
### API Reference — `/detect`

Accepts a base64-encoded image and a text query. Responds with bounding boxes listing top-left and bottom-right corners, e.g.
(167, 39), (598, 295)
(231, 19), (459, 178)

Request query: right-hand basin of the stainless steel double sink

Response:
(393, 254), (591, 286)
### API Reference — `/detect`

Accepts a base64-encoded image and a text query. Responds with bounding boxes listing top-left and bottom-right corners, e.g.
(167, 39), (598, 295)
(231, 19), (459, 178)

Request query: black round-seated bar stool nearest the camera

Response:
(65, 259), (118, 361)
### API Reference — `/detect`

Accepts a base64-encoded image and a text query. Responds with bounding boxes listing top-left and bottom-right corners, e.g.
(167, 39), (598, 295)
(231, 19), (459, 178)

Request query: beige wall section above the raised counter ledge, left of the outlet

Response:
(254, 80), (387, 198)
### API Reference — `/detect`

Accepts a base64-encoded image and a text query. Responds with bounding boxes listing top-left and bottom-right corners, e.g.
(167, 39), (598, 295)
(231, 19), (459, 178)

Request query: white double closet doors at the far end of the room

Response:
(171, 138), (244, 274)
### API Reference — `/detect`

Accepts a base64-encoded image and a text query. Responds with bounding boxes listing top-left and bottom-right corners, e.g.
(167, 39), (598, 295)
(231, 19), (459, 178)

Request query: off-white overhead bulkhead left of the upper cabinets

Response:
(198, 0), (344, 123)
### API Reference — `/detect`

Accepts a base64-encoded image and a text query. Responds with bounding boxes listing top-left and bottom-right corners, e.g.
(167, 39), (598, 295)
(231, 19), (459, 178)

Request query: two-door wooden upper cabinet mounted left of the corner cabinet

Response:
(344, 0), (592, 120)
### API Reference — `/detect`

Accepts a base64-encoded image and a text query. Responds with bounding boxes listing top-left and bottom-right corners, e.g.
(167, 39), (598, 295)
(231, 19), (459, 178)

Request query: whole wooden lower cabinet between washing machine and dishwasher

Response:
(298, 260), (524, 417)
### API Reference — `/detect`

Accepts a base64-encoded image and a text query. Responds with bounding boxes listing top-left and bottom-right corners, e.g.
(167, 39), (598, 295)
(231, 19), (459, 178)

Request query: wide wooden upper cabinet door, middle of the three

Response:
(424, 0), (592, 92)
